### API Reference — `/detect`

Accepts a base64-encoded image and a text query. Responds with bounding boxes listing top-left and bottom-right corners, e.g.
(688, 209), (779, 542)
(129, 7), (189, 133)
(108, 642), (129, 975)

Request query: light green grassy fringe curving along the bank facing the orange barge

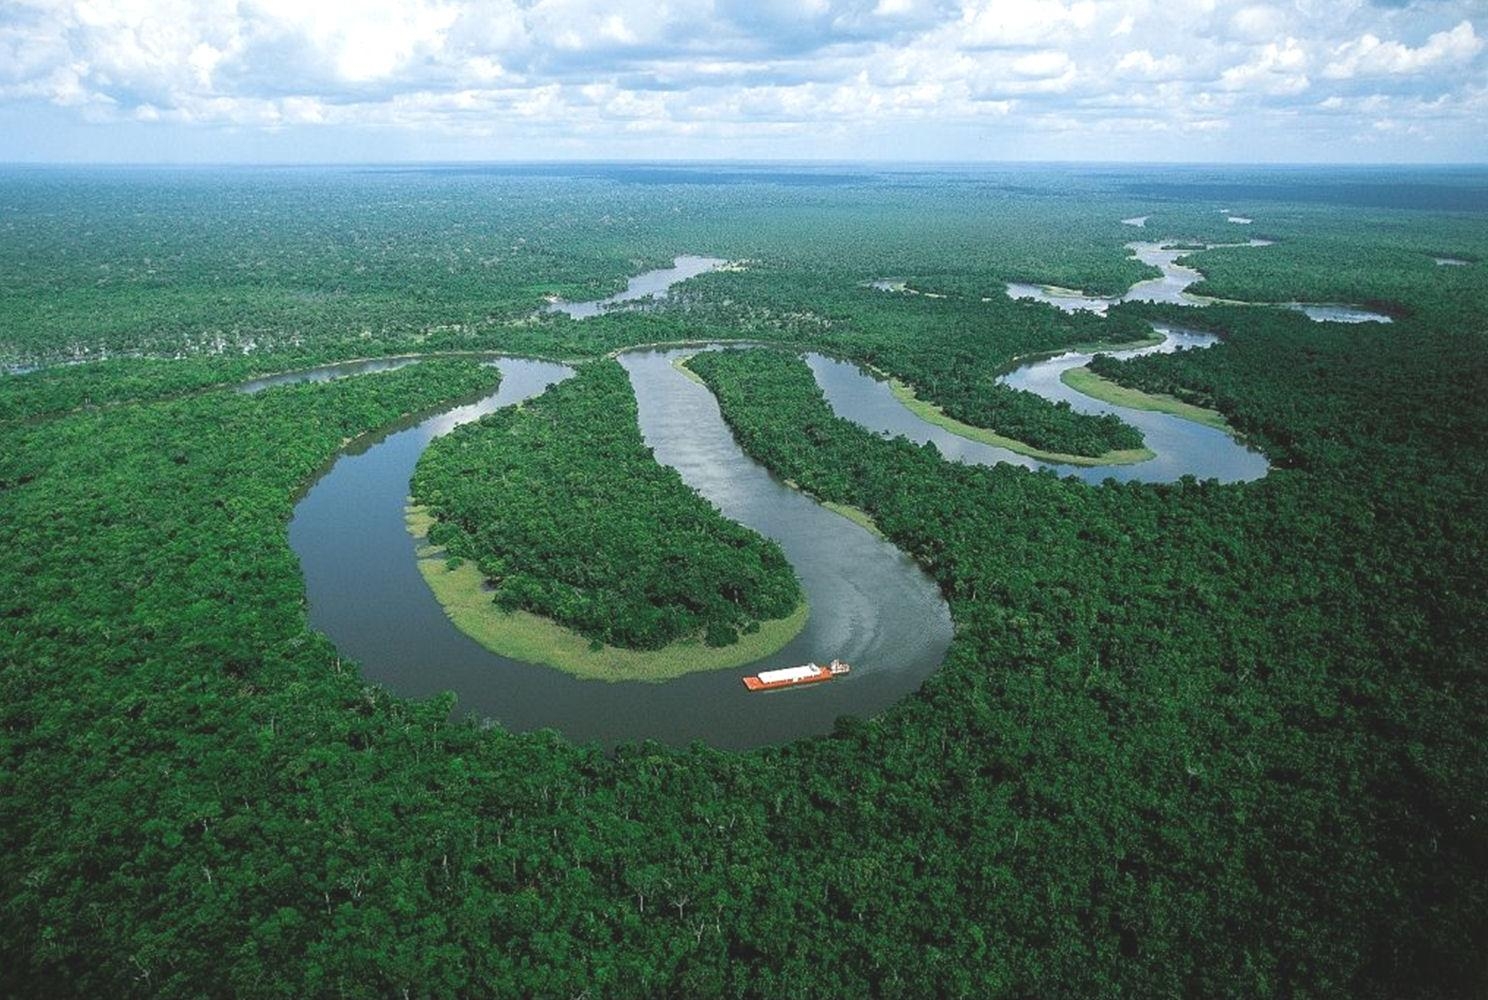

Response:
(406, 506), (811, 682)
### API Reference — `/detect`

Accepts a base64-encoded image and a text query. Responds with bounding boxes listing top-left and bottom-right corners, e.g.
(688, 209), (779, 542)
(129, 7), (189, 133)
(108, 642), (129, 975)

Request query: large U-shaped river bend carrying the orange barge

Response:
(290, 348), (951, 749)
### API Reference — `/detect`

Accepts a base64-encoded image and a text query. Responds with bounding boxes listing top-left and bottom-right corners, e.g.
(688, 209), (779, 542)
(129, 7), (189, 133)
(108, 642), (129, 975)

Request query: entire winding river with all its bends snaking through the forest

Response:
(261, 239), (1285, 749)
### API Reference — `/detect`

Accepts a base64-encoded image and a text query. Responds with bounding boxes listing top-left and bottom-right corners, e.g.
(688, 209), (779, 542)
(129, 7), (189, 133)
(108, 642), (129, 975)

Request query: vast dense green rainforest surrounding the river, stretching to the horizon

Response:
(0, 168), (1488, 999)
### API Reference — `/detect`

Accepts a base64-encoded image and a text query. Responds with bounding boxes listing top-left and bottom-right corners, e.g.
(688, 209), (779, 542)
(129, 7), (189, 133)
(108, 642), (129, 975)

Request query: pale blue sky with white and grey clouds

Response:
(0, 0), (1488, 162)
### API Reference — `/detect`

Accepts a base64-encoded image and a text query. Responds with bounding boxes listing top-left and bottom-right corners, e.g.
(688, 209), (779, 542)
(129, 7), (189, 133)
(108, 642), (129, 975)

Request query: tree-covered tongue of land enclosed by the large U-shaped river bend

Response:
(414, 359), (804, 651)
